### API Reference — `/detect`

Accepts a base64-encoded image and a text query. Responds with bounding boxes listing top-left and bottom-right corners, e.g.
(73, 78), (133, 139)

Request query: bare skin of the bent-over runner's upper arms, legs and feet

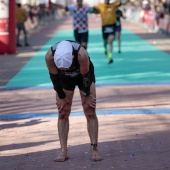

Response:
(45, 47), (102, 162)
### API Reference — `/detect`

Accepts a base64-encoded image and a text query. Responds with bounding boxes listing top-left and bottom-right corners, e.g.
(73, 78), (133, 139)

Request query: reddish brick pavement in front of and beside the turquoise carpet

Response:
(0, 15), (170, 170)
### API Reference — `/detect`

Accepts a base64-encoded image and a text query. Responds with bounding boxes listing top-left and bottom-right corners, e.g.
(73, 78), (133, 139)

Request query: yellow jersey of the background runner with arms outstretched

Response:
(94, 1), (121, 26)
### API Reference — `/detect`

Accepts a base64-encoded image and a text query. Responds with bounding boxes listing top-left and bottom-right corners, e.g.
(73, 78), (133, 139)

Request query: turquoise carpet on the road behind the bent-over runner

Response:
(5, 29), (170, 88)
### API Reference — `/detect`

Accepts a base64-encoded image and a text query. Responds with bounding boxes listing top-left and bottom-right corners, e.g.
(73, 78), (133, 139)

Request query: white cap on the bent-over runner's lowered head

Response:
(54, 41), (73, 69)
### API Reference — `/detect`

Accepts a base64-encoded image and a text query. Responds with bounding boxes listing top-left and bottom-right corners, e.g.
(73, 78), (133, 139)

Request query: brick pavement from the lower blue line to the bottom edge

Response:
(0, 114), (170, 170)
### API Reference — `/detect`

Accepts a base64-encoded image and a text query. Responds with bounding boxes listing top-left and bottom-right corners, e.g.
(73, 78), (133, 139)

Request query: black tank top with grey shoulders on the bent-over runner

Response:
(51, 40), (82, 77)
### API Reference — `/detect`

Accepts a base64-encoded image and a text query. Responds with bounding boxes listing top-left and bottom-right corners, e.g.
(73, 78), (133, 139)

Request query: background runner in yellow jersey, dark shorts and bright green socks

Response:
(94, 0), (121, 64)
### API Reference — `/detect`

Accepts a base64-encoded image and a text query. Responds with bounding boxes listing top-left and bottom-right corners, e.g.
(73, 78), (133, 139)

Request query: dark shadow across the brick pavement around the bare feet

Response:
(0, 131), (170, 170)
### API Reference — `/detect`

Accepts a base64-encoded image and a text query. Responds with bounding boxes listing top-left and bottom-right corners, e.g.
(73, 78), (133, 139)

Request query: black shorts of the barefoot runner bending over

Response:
(60, 61), (96, 91)
